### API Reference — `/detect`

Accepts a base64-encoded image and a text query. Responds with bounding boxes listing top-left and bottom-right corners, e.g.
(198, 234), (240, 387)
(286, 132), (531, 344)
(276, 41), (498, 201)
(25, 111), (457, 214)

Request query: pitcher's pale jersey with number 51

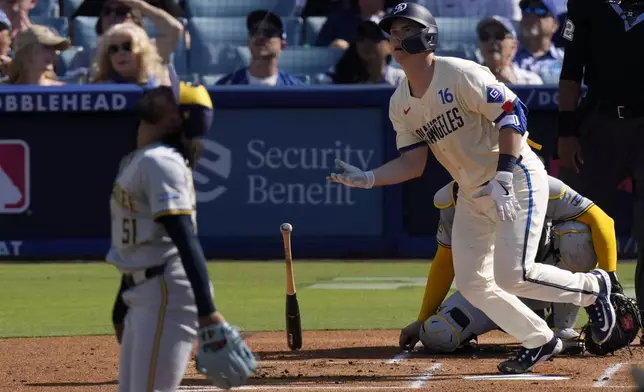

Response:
(107, 144), (196, 272)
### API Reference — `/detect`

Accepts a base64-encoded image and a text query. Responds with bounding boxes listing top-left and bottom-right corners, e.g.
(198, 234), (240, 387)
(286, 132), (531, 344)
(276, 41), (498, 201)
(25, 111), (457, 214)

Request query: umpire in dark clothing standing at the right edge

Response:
(557, 0), (644, 316)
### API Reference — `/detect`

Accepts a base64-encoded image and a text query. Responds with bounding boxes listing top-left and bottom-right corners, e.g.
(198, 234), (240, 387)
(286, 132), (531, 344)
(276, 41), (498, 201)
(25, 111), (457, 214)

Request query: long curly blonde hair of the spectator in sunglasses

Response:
(91, 22), (167, 84)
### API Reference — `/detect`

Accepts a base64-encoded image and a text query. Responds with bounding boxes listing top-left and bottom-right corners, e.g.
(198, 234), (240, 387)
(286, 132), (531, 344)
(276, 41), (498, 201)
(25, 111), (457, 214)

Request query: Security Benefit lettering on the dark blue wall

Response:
(246, 139), (375, 205)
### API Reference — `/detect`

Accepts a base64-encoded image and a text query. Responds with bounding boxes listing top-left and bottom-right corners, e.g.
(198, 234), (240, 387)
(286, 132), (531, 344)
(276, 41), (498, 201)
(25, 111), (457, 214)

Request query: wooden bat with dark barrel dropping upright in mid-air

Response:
(280, 223), (302, 351)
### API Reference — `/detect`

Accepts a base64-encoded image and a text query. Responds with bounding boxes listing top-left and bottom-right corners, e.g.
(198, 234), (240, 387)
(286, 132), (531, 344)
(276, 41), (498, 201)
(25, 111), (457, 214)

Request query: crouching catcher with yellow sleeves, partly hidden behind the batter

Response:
(400, 176), (617, 353)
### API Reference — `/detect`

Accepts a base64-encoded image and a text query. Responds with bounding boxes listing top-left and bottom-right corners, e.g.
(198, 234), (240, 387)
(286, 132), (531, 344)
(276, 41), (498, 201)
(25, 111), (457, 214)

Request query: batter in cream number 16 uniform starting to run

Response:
(329, 3), (615, 373)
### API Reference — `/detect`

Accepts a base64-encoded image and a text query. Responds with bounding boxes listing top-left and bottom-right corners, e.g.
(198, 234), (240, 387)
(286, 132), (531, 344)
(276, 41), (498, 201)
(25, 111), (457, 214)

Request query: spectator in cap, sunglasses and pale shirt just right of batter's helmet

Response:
(476, 15), (543, 85)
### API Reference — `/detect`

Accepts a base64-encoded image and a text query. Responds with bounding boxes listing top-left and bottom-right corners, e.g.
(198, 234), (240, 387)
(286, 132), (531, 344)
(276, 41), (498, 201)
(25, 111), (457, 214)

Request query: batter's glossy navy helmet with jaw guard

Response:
(378, 3), (438, 54)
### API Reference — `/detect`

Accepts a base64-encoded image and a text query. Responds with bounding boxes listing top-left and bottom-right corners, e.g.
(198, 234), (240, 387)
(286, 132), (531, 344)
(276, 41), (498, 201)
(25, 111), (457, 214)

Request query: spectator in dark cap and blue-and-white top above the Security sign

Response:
(217, 10), (304, 86)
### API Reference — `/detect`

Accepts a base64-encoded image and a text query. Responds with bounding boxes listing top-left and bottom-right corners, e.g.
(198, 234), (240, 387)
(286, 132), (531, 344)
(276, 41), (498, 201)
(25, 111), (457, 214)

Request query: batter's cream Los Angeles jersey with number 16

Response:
(389, 56), (529, 188)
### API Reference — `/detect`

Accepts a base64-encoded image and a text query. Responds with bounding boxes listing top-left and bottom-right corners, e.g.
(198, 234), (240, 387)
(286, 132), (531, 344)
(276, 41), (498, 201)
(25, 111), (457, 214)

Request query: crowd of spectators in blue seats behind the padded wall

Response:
(0, 0), (566, 86)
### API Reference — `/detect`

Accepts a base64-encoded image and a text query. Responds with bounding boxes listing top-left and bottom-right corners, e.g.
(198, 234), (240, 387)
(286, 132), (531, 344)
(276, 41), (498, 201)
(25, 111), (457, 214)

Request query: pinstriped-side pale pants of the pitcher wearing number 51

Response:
(119, 258), (199, 392)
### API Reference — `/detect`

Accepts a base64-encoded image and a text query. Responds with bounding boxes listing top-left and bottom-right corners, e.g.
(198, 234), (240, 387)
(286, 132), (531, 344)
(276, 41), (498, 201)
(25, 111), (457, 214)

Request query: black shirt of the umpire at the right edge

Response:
(560, 0), (644, 107)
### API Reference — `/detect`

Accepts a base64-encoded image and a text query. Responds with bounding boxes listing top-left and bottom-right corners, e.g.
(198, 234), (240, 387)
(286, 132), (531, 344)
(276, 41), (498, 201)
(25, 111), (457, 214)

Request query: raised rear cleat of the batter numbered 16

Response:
(586, 269), (615, 344)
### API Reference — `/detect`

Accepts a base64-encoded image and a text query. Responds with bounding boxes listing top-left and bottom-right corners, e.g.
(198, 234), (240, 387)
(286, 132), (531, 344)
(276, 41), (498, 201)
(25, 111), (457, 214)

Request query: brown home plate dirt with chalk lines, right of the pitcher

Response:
(180, 331), (644, 392)
